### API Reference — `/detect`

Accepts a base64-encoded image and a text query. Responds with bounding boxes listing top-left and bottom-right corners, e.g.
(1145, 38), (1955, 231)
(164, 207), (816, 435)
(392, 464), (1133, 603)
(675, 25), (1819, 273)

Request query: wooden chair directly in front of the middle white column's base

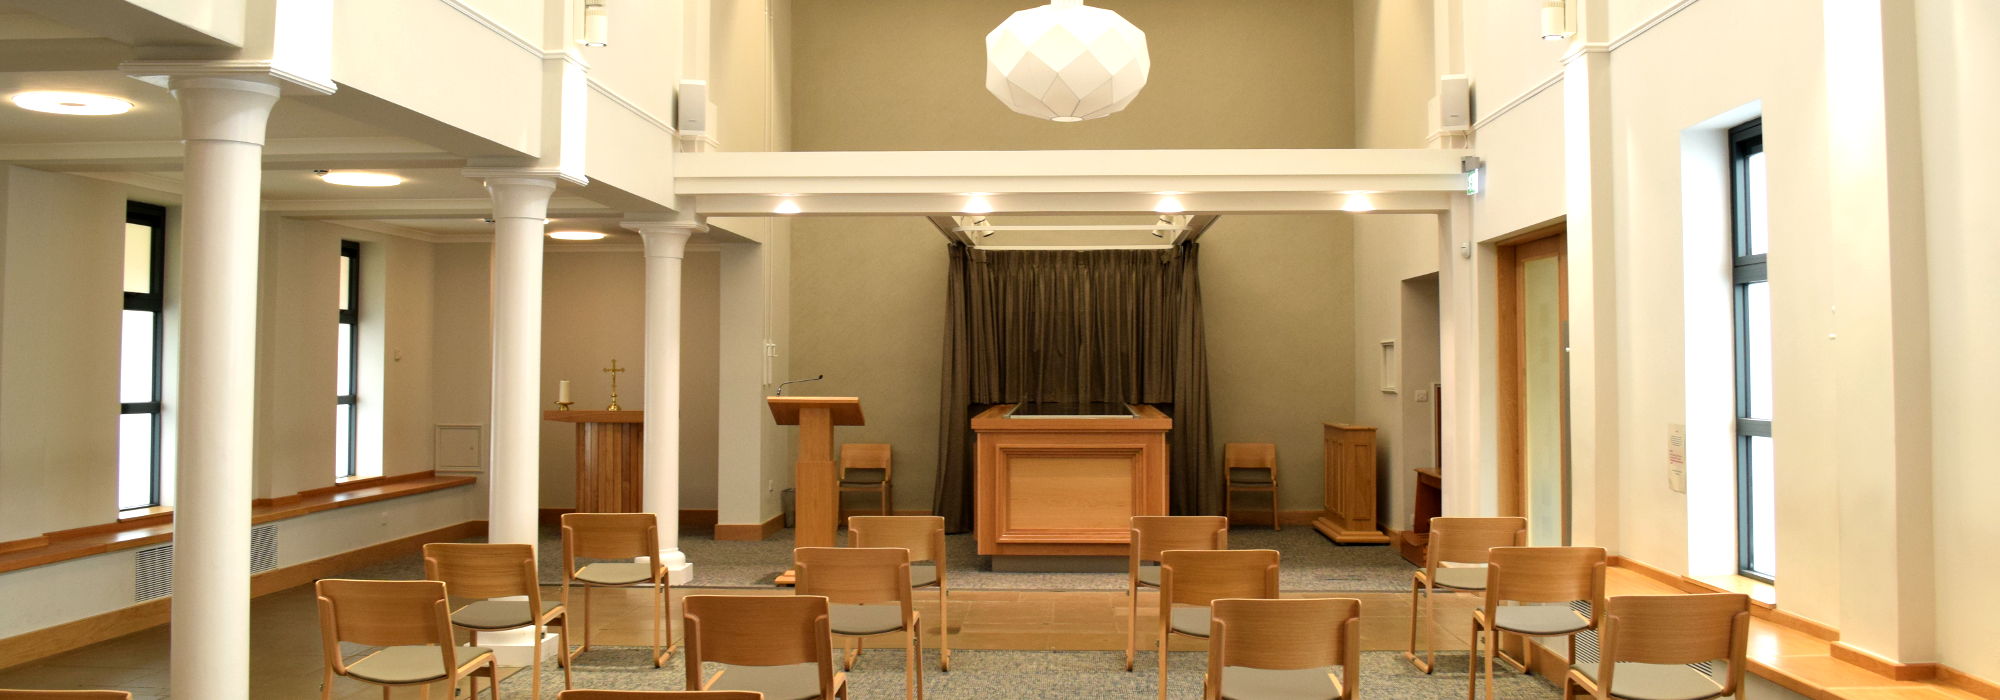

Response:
(424, 542), (570, 698)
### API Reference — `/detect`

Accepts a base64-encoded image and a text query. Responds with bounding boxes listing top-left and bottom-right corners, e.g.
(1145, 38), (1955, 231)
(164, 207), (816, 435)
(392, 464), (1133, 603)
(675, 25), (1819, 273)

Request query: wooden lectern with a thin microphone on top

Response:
(770, 396), (862, 586)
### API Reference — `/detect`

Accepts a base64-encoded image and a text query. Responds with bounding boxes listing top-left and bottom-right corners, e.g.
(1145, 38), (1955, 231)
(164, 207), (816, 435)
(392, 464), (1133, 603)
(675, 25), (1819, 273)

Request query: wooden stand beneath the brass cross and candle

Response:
(542, 410), (646, 512)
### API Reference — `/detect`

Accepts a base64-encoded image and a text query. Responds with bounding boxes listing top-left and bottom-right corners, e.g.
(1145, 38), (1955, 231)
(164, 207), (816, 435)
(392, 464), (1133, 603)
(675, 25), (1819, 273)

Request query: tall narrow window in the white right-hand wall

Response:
(1730, 120), (1778, 582)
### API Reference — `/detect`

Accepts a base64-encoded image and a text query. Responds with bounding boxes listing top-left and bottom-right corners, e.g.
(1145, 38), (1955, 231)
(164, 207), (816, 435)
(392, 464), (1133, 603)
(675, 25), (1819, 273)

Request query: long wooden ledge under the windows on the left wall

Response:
(0, 472), (478, 574)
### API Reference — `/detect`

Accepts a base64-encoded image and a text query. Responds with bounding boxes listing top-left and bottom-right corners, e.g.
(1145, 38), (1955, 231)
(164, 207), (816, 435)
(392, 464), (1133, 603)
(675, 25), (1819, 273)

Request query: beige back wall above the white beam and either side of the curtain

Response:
(788, 0), (1354, 510)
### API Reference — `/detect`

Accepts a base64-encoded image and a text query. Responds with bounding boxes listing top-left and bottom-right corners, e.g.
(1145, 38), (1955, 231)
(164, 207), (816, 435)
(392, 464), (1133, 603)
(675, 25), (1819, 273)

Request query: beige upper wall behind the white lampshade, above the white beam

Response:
(796, 0), (1354, 150)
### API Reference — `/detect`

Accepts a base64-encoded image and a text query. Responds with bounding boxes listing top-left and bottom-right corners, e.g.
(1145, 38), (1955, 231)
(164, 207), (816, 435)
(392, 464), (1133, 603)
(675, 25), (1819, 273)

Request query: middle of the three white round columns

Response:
(466, 168), (556, 544)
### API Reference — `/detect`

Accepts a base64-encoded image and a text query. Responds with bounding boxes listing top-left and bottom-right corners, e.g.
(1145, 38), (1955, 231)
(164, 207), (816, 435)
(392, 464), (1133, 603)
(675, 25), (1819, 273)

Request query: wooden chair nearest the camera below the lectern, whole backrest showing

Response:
(680, 596), (848, 700)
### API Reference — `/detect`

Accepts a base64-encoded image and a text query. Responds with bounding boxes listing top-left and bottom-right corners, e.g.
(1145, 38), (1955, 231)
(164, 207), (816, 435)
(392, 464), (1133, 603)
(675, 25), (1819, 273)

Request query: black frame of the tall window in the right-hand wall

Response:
(1728, 118), (1776, 584)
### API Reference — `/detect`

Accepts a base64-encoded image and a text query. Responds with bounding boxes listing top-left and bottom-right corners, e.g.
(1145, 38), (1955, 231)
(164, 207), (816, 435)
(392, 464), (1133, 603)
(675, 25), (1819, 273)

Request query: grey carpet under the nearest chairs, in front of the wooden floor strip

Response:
(488, 642), (1558, 700)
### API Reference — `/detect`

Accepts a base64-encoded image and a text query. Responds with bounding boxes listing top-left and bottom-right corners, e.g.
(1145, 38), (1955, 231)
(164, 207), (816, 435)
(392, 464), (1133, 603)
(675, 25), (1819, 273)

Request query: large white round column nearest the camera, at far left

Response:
(168, 76), (278, 700)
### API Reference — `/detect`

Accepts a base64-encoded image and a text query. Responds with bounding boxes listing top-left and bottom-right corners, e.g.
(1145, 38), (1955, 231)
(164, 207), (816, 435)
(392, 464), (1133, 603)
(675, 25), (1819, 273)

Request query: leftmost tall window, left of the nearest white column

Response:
(118, 202), (166, 510)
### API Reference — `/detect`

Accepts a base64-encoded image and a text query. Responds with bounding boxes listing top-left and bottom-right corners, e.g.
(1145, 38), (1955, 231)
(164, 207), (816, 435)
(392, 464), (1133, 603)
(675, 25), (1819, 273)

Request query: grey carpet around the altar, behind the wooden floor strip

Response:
(350, 526), (1416, 592)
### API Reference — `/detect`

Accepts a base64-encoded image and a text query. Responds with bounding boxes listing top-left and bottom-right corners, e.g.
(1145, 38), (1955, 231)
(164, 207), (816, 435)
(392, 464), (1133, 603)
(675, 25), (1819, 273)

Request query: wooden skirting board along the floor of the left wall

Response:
(0, 520), (486, 668)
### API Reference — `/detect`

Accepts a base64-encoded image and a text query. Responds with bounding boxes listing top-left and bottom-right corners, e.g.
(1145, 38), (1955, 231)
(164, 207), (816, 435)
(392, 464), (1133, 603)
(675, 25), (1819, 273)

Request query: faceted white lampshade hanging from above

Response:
(986, 0), (1152, 122)
